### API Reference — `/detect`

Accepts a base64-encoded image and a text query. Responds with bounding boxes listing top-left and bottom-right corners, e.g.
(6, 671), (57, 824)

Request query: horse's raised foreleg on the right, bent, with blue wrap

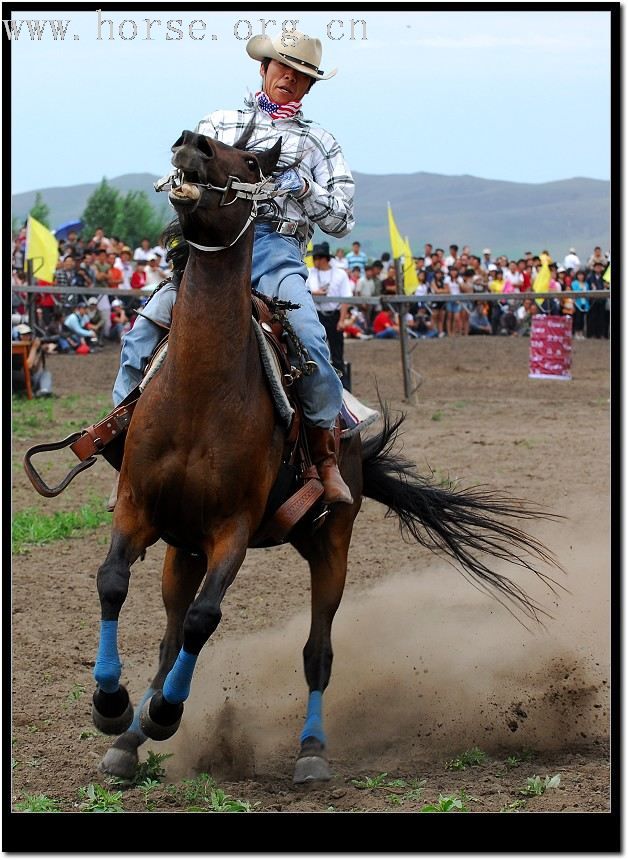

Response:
(140, 529), (248, 741)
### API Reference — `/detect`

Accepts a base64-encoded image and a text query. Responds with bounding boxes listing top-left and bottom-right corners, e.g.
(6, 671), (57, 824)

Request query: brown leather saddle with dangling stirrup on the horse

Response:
(24, 293), (342, 547)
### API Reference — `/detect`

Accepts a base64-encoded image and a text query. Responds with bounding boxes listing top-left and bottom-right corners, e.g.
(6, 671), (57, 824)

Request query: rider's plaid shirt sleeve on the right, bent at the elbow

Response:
(298, 130), (355, 237)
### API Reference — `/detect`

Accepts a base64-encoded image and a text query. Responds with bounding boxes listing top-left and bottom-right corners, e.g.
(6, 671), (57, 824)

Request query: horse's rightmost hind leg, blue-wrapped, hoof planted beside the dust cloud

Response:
(294, 505), (356, 783)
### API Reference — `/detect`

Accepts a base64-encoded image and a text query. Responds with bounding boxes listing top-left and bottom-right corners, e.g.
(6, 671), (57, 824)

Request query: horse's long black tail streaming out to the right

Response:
(362, 404), (563, 622)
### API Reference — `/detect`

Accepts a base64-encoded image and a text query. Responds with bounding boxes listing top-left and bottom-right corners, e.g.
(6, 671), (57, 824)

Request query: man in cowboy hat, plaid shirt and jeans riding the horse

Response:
(110, 31), (354, 507)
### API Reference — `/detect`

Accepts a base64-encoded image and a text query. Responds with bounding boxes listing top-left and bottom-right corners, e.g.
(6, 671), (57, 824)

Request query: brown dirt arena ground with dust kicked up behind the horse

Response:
(11, 338), (611, 832)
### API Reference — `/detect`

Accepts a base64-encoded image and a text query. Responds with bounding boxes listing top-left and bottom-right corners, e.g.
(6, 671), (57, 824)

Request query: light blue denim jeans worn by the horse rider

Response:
(113, 222), (342, 429)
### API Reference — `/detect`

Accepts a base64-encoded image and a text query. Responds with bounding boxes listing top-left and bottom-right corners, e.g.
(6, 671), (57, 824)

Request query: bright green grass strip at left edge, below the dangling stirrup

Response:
(11, 499), (111, 555)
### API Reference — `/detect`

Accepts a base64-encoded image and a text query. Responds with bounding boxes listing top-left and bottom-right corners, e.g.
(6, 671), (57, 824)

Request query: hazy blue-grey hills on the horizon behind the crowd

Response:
(12, 173), (610, 258)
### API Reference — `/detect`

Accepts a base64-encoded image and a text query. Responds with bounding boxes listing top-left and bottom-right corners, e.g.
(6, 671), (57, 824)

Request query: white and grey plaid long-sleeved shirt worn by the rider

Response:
(196, 104), (355, 247)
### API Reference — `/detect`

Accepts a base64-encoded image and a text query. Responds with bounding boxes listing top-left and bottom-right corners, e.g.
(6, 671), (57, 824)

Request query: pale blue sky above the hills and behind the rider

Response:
(8, 3), (611, 193)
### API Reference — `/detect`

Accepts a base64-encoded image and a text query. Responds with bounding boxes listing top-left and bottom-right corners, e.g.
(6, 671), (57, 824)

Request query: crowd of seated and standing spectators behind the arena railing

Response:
(12, 229), (610, 369)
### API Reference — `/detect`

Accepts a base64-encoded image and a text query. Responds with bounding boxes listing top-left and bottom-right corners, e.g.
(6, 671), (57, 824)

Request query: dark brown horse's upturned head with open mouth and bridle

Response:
(169, 131), (281, 250)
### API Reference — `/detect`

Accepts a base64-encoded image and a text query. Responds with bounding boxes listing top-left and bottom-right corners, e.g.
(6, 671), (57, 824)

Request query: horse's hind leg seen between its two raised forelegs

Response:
(100, 547), (206, 779)
